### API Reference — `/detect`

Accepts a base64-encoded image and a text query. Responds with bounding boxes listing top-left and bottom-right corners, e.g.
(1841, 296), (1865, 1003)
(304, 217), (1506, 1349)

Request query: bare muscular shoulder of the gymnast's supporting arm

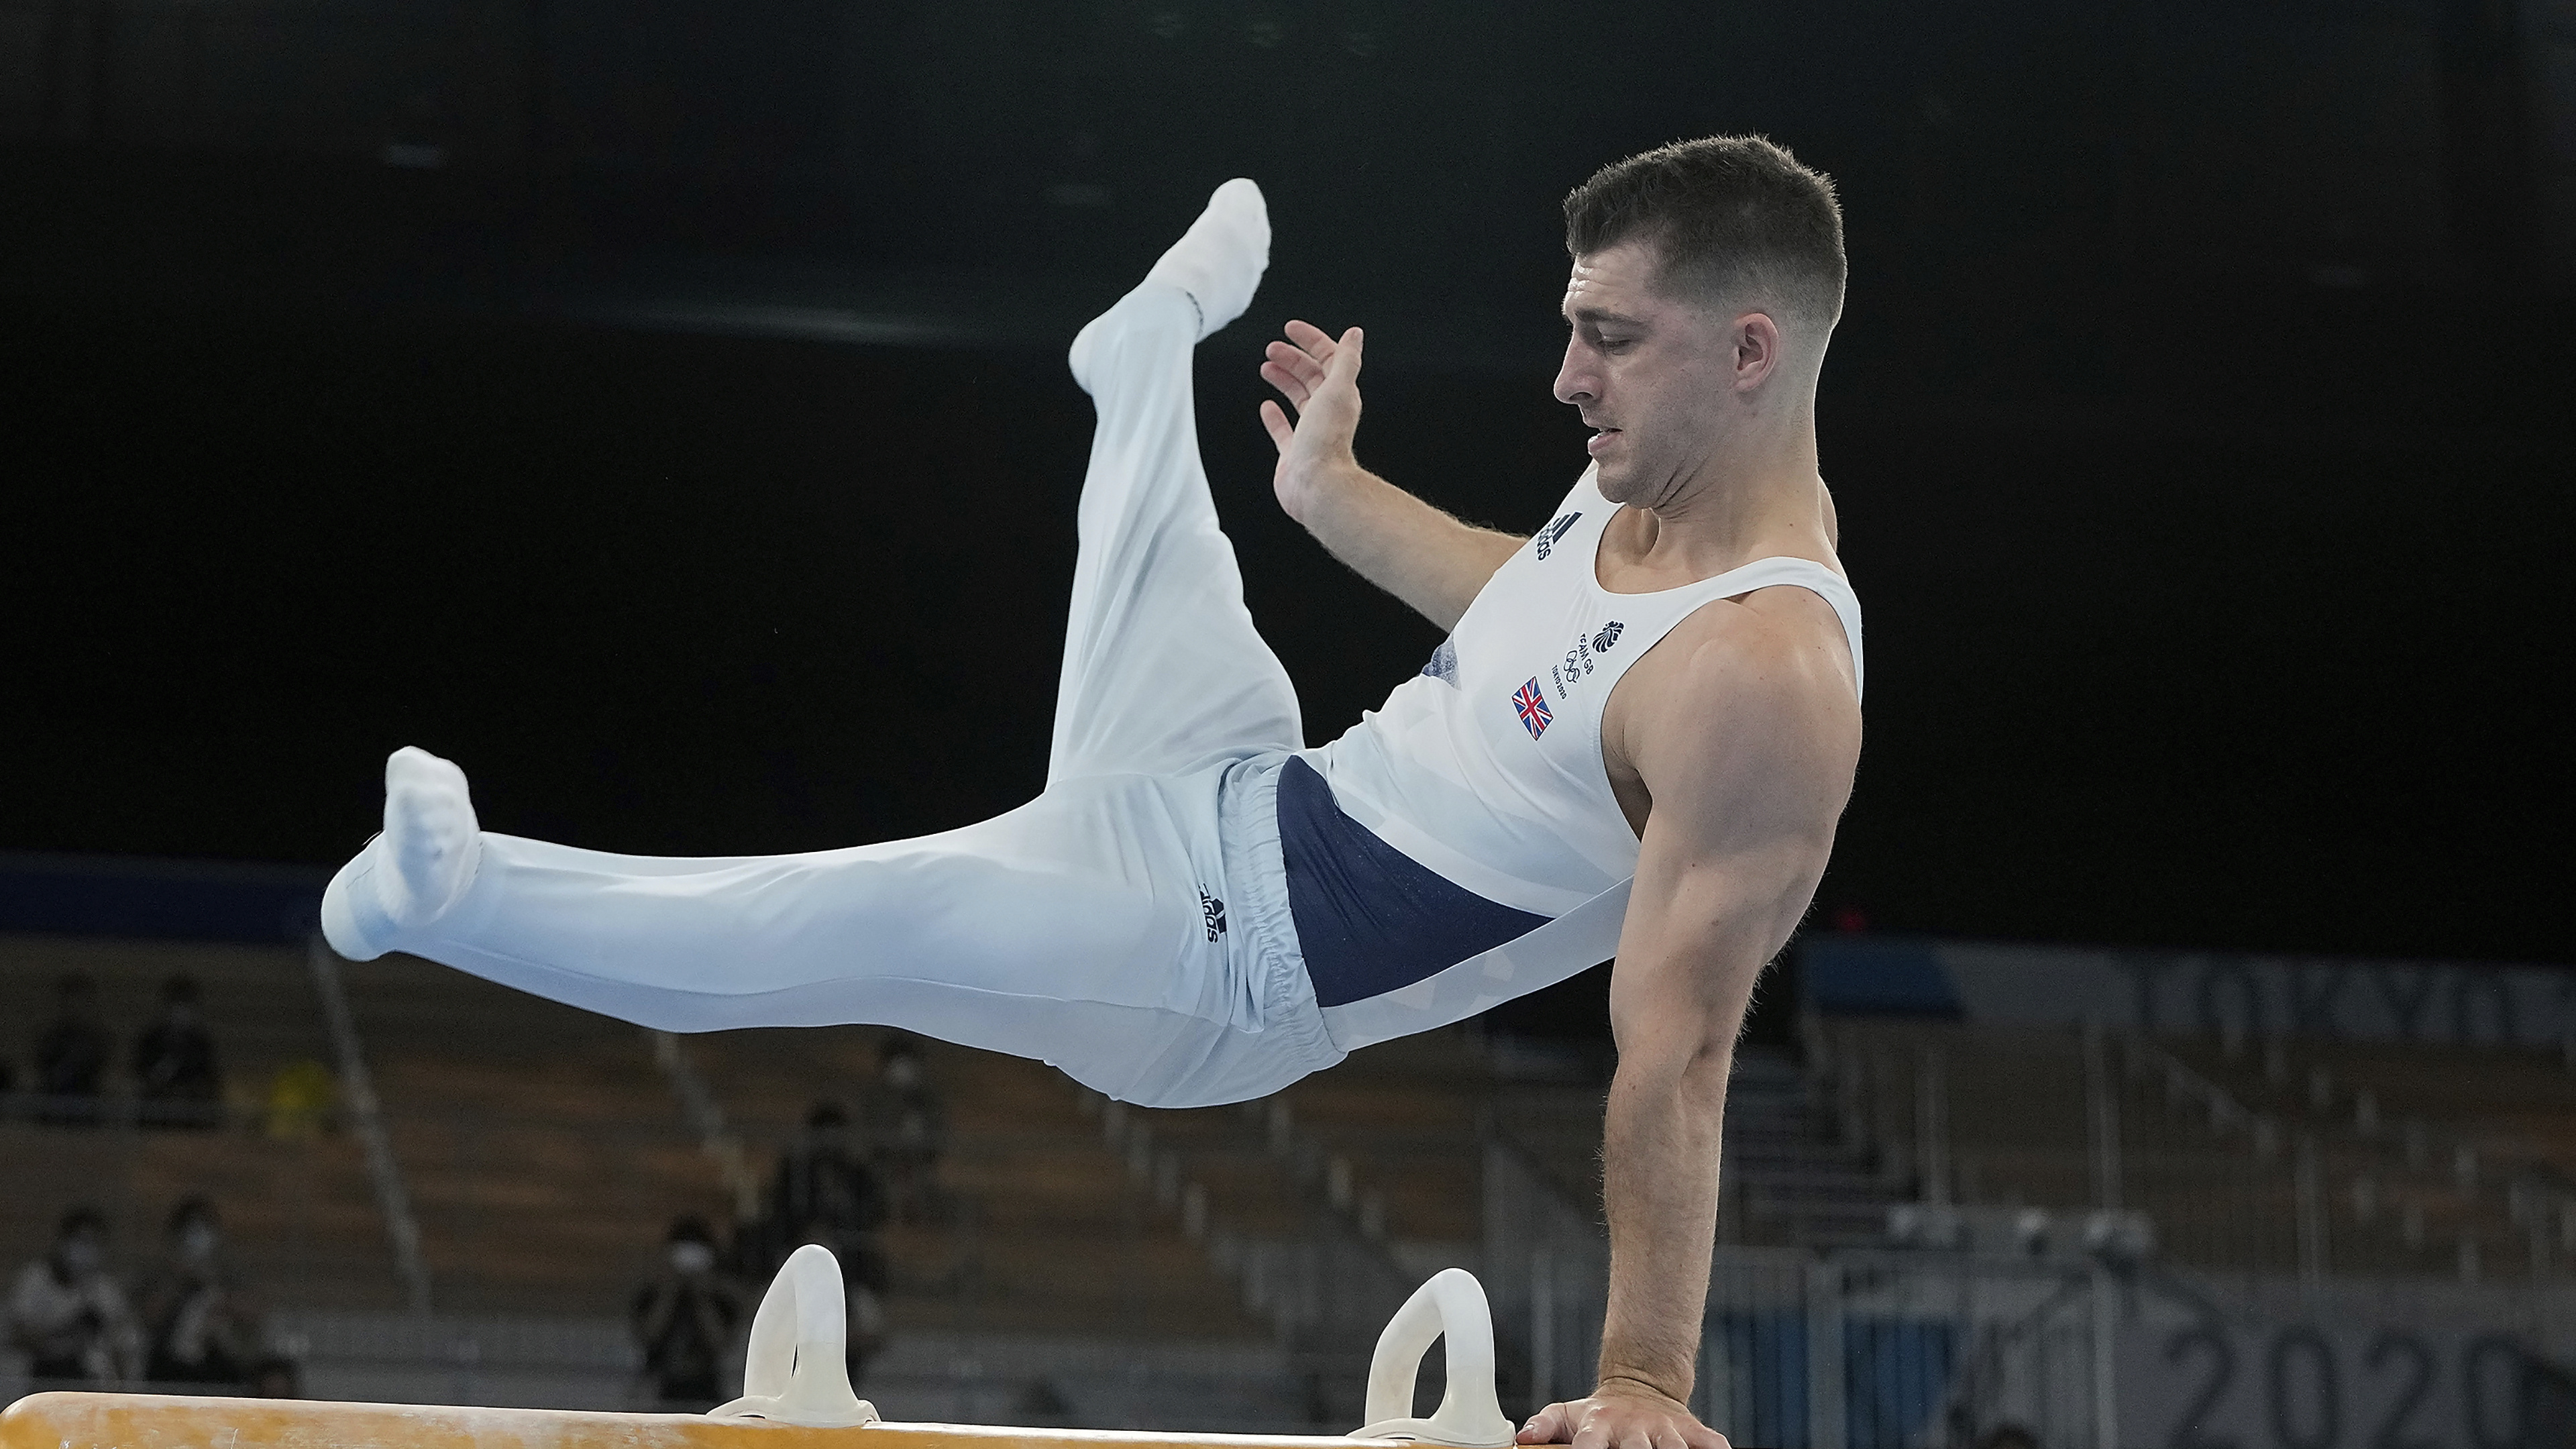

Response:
(1615, 588), (1860, 830)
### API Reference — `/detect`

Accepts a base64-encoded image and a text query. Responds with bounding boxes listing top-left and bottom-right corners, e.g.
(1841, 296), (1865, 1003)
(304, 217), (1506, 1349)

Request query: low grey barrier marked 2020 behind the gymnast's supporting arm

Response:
(1487, 1124), (2576, 1449)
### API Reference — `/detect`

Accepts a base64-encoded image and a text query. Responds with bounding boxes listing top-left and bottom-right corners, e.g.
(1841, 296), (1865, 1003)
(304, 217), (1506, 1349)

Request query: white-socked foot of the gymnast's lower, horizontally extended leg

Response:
(322, 745), (482, 962)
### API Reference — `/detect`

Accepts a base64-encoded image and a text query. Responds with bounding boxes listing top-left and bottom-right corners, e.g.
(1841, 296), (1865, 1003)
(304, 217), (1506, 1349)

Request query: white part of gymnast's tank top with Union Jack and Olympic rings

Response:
(1301, 470), (1862, 1049)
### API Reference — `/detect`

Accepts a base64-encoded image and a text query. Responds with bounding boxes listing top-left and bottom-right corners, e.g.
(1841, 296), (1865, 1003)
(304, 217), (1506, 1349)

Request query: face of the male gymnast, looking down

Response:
(1556, 242), (1778, 508)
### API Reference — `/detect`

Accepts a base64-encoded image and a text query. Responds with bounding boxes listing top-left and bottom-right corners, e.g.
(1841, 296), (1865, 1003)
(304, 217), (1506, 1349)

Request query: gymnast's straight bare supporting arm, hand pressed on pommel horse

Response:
(1520, 629), (1860, 1449)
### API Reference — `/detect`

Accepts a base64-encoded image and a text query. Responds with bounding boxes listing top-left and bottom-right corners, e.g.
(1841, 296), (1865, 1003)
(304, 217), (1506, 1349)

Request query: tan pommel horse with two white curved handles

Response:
(0, 1243), (1512, 1449)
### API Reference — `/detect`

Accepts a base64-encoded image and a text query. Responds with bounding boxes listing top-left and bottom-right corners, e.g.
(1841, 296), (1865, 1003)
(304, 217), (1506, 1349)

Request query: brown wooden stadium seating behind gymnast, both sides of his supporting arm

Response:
(25, 907), (2576, 1428)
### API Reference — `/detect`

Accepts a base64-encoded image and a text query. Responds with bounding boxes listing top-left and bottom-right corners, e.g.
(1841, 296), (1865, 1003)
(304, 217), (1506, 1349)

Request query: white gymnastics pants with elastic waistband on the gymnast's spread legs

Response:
(337, 284), (1342, 1106)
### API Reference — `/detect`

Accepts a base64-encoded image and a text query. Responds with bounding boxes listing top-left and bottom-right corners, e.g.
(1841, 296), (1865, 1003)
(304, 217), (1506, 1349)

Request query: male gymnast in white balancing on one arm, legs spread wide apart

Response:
(322, 137), (1862, 1449)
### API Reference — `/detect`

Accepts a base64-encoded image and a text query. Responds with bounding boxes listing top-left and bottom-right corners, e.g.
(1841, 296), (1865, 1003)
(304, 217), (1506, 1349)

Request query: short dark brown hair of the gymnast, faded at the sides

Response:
(1566, 137), (1849, 327)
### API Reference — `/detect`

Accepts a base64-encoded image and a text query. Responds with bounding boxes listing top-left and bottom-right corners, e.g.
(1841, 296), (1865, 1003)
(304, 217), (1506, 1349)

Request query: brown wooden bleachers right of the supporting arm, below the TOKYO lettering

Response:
(1831, 1018), (2576, 1276)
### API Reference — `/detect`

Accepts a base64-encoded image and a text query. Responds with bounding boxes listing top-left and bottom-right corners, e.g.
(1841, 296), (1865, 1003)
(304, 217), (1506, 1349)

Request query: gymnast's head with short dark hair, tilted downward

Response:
(1556, 137), (1844, 508)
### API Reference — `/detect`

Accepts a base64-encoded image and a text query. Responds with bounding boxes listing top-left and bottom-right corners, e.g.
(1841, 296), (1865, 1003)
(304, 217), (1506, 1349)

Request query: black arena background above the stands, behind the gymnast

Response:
(0, 0), (2576, 985)
